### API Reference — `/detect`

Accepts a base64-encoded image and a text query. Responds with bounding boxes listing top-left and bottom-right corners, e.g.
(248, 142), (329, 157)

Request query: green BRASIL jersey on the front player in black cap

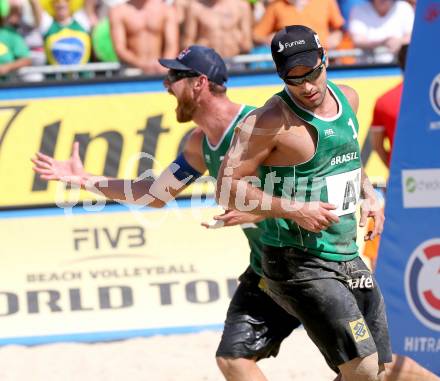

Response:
(261, 81), (361, 261)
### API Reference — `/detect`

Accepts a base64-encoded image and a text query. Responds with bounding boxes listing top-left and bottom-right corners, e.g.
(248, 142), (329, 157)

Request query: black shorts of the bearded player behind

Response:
(216, 267), (301, 360)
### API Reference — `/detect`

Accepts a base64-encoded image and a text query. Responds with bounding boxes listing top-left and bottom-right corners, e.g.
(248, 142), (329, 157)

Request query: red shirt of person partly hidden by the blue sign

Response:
(371, 82), (403, 166)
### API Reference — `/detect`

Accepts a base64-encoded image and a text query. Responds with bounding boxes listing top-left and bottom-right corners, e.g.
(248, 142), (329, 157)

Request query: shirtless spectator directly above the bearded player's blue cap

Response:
(183, 0), (252, 58)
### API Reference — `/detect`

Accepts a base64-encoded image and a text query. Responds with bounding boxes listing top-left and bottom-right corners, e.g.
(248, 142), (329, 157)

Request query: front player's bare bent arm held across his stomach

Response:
(216, 106), (338, 232)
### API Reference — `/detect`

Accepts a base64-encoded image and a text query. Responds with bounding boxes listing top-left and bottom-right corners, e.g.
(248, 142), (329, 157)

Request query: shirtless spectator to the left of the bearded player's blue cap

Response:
(109, 0), (179, 74)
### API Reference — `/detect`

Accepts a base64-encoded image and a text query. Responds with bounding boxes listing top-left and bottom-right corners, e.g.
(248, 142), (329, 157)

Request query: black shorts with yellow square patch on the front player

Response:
(263, 246), (392, 370)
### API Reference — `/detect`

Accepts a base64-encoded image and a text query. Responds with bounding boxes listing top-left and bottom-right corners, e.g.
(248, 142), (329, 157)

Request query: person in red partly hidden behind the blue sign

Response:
(370, 45), (408, 167)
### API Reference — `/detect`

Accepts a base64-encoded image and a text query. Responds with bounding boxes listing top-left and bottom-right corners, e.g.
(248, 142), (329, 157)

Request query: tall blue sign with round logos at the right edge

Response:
(377, 0), (440, 375)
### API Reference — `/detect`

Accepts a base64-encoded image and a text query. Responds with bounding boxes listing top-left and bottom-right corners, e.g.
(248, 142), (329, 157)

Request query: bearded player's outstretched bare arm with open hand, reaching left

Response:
(32, 130), (206, 208)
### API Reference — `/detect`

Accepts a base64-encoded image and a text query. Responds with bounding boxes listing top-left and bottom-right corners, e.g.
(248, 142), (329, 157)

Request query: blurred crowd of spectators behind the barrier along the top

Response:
(0, 0), (415, 84)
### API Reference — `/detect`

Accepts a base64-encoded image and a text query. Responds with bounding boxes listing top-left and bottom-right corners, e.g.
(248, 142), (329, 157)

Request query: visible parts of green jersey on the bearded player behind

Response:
(203, 106), (263, 275)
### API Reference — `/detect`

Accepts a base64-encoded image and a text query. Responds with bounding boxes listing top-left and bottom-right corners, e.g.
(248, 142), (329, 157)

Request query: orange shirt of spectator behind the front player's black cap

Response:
(254, 0), (344, 46)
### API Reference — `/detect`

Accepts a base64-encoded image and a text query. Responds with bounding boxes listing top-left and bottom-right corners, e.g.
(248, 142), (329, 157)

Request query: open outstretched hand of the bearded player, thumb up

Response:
(31, 142), (87, 185)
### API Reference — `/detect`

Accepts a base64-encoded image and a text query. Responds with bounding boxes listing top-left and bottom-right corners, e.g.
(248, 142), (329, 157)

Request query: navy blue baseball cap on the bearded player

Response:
(159, 45), (228, 85)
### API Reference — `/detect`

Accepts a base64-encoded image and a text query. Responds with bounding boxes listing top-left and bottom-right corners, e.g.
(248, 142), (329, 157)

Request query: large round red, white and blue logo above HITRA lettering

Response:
(405, 238), (440, 331)
